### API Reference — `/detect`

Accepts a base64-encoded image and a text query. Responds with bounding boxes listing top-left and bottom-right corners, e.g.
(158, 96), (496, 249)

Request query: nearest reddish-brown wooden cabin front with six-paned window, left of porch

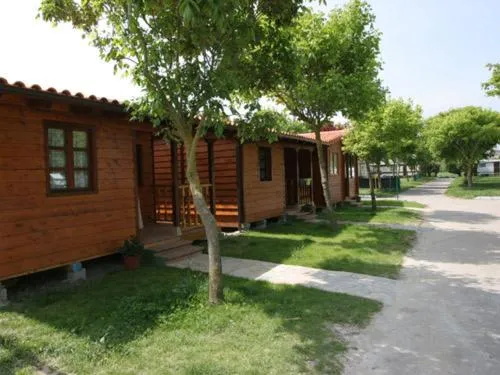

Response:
(0, 79), (154, 280)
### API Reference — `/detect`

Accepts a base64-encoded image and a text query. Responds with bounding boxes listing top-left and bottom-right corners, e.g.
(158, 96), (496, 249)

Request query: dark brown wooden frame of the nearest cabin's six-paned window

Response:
(43, 120), (97, 196)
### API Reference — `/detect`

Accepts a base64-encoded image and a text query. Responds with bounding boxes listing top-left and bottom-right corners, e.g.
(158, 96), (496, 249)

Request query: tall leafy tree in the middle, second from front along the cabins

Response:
(270, 0), (383, 209)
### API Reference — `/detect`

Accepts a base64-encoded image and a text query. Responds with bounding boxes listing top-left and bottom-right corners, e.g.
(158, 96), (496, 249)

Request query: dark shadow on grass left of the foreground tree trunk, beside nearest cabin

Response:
(8, 267), (205, 347)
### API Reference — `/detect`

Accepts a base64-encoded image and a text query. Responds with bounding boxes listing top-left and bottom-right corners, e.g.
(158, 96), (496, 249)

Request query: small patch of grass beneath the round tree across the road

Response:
(446, 176), (500, 199)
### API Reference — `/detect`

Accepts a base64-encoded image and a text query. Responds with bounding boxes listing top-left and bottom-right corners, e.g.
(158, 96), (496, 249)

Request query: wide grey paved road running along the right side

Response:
(346, 180), (500, 375)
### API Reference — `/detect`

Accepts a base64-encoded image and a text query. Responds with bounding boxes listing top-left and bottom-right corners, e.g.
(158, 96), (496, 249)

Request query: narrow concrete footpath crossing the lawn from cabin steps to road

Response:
(169, 254), (397, 305)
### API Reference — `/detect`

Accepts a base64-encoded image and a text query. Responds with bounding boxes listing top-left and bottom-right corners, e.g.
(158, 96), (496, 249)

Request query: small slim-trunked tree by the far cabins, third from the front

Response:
(344, 111), (387, 211)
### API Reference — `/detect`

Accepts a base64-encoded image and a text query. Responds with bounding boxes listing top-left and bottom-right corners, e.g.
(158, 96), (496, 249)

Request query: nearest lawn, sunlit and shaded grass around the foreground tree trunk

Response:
(0, 267), (381, 375)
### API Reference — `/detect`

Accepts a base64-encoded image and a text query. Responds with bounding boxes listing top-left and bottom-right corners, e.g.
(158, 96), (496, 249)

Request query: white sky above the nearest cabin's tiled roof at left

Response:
(0, 0), (140, 100)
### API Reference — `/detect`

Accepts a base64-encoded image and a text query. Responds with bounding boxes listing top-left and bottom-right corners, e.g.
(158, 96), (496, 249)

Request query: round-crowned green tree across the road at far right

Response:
(426, 106), (500, 187)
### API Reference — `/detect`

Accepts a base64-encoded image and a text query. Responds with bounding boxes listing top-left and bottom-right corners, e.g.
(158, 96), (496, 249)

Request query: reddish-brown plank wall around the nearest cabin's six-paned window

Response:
(0, 94), (143, 279)
